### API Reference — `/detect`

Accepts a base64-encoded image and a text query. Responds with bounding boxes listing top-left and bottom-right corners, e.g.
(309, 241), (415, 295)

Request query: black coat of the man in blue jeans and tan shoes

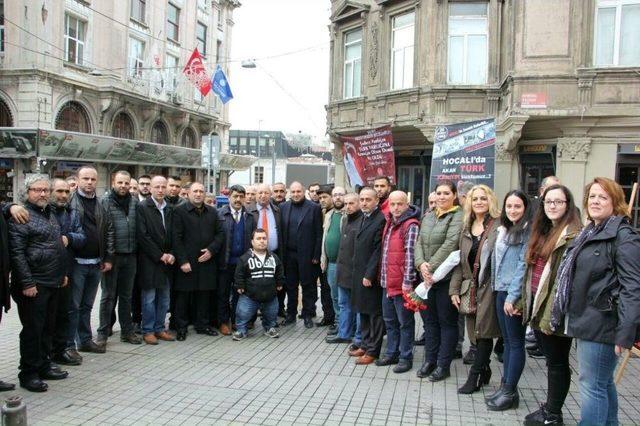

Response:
(136, 197), (174, 290)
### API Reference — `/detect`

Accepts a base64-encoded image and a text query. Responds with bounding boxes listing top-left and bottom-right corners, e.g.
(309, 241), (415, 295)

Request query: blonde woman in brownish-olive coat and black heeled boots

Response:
(450, 185), (500, 394)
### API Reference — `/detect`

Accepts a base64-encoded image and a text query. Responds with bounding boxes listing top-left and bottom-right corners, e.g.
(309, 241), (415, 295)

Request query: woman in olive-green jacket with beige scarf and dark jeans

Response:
(415, 181), (462, 382)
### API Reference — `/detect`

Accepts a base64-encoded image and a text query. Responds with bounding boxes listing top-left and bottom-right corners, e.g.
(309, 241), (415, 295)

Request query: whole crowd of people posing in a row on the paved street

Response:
(0, 170), (640, 425)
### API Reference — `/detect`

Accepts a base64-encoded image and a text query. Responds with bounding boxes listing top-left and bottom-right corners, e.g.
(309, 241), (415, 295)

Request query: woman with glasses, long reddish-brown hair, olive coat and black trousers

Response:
(522, 185), (582, 426)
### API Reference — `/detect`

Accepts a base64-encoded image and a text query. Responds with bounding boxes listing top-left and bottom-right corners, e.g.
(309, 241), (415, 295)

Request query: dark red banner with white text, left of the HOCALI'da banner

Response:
(340, 126), (396, 187)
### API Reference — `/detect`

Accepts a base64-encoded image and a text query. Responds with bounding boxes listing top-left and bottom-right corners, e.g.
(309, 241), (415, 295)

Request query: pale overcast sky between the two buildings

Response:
(228, 0), (331, 142)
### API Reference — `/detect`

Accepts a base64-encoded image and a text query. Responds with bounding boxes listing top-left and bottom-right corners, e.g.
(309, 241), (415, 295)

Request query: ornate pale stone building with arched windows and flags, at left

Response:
(0, 0), (245, 198)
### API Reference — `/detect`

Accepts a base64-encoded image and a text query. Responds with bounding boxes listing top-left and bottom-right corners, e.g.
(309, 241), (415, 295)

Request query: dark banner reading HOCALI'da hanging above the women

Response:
(429, 118), (496, 191)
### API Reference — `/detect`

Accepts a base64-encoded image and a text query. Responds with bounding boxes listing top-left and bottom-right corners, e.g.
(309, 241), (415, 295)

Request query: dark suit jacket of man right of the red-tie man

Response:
(280, 199), (322, 282)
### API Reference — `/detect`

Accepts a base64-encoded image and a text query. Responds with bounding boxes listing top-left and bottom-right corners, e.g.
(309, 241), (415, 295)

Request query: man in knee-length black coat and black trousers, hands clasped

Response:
(173, 182), (224, 341)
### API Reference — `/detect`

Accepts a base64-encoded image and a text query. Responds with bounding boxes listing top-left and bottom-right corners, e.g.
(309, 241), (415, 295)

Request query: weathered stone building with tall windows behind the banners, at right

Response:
(327, 0), (640, 226)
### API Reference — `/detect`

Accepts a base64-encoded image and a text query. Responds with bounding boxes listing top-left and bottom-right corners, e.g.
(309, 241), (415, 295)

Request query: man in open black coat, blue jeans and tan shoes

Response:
(136, 176), (175, 345)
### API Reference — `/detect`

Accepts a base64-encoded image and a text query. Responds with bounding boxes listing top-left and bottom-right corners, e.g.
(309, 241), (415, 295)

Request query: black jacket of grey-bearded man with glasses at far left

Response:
(9, 203), (67, 291)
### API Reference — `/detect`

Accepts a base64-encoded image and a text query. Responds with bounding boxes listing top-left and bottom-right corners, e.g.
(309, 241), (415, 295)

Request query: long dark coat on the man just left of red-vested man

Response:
(351, 209), (386, 314)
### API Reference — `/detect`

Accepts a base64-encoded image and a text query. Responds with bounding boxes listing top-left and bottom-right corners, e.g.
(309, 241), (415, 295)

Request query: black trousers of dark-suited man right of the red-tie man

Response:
(284, 252), (319, 318)
